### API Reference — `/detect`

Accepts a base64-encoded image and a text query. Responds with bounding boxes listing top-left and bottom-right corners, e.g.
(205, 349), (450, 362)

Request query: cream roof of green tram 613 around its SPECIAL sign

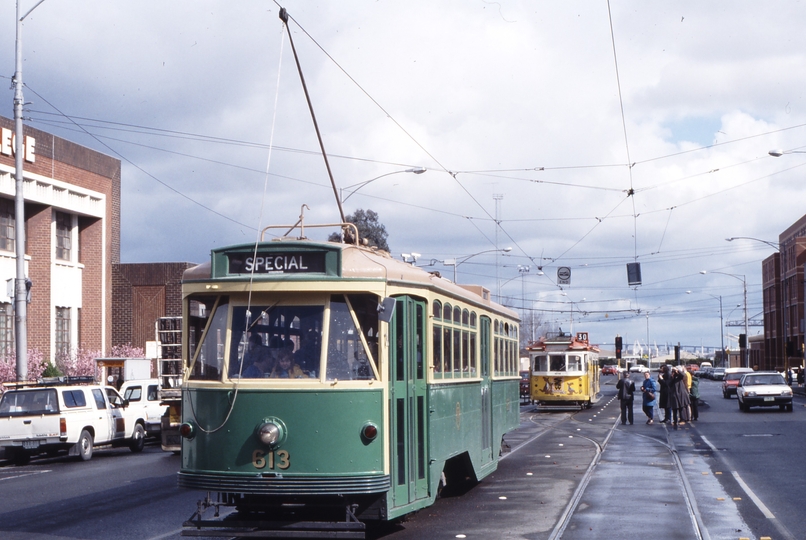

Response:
(182, 238), (520, 319)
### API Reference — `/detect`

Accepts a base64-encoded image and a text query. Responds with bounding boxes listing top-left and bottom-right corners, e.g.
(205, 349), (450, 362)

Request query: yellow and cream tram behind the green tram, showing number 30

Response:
(527, 332), (601, 408)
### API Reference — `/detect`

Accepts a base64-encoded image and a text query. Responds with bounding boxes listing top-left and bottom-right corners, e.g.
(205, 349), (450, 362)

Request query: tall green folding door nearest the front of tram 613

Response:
(389, 296), (428, 507)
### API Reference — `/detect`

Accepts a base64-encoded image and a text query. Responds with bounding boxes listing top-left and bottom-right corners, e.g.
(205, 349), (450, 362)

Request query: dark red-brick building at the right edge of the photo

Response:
(761, 215), (806, 370)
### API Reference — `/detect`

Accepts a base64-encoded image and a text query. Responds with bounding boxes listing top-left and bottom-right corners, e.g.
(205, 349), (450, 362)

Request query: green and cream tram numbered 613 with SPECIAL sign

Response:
(179, 224), (520, 538)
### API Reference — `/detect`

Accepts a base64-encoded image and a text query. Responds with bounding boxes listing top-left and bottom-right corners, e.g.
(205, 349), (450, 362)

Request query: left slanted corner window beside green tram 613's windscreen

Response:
(188, 296), (229, 381)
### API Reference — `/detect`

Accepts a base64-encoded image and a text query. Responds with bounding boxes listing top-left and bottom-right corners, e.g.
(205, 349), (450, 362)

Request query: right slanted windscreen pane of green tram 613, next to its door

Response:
(325, 295), (377, 381)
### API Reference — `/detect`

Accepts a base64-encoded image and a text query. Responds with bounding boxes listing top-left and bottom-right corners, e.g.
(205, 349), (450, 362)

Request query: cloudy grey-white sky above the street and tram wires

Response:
(0, 0), (806, 349)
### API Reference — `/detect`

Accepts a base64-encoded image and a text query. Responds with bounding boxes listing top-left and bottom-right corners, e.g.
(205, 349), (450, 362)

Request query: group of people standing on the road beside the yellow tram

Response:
(616, 365), (700, 429)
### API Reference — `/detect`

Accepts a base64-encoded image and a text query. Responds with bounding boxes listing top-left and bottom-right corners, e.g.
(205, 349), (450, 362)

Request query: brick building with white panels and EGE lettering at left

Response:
(0, 117), (121, 361)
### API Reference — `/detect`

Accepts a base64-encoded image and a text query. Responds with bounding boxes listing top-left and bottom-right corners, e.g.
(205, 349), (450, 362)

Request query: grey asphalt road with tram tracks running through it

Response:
(0, 375), (806, 540)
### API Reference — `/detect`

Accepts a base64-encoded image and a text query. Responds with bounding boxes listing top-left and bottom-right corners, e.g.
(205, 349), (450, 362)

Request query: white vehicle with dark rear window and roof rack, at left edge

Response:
(0, 381), (146, 464)
